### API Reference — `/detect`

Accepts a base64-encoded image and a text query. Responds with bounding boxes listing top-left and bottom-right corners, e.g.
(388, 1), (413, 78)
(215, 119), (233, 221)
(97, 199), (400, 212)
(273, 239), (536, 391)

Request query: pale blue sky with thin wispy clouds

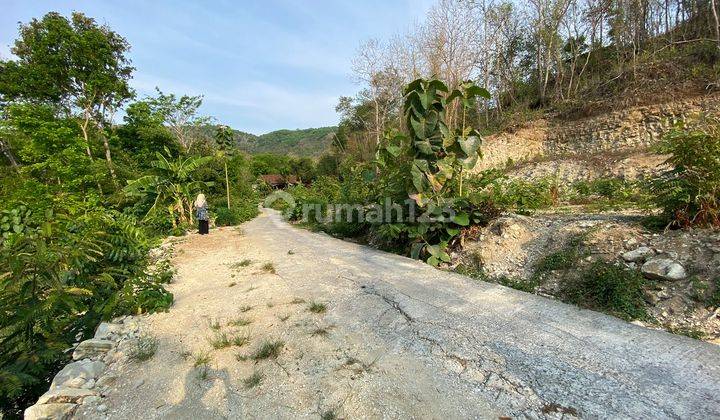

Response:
(0, 0), (432, 134)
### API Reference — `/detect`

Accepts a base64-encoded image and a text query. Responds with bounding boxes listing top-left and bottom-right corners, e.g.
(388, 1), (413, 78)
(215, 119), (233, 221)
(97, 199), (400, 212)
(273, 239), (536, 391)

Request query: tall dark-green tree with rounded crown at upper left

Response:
(0, 12), (134, 181)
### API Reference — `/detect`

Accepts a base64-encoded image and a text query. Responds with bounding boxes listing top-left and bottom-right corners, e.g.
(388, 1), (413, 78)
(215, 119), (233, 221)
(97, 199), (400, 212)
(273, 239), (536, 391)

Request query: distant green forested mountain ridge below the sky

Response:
(235, 127), (337, 157)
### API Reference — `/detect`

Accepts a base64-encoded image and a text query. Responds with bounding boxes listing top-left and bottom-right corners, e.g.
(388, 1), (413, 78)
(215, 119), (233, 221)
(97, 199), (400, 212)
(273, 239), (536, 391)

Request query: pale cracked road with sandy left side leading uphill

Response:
(87, 208), (720, 419)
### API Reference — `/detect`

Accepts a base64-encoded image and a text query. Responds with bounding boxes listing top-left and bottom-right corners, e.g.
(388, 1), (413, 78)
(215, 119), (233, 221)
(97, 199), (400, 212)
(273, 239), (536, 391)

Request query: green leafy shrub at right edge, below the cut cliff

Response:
(653, 119), (720, 227)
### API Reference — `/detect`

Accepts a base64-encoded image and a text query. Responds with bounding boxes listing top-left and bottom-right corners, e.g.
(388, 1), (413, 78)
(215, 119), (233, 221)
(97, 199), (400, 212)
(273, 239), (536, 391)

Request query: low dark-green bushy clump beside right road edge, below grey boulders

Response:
(561, 261), (647, 320)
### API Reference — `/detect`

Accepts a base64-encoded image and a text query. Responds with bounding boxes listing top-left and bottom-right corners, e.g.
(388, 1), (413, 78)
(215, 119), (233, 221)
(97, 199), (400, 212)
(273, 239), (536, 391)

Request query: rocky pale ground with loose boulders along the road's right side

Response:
(456, 211), (720, 344)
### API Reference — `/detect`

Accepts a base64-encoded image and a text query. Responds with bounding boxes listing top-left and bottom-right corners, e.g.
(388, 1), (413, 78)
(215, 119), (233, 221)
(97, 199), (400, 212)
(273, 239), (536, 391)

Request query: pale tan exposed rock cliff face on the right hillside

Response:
(475, 94), (720, 181)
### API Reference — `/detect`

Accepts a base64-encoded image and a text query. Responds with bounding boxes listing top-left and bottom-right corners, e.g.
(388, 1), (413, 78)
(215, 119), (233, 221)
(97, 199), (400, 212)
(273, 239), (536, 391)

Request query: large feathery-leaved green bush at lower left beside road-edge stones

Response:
(0, 203), (172, 410)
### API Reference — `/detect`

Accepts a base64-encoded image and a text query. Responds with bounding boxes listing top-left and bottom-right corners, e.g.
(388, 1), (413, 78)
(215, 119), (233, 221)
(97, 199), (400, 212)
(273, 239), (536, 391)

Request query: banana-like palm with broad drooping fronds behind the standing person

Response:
(124, 148), (213, 228)
